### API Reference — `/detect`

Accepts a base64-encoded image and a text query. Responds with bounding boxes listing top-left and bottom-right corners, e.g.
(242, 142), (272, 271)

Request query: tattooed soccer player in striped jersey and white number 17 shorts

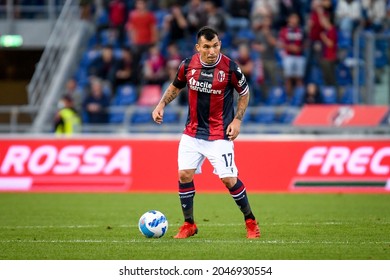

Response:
(152, 26), (260, 238)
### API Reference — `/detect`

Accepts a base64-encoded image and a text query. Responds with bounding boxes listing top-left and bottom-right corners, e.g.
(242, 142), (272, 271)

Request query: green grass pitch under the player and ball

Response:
(0, 193), (390, 260)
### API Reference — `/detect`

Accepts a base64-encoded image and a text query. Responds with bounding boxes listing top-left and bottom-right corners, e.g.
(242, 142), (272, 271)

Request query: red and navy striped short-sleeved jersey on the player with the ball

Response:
(173, 54), (249, 140)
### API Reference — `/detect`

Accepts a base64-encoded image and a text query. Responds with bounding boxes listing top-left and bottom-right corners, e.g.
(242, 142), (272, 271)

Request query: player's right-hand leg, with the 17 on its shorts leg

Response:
(206, 140), (260, 238)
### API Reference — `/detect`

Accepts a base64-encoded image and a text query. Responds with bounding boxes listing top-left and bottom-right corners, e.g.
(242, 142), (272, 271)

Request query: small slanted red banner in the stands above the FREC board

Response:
(294, 105), (389, 126)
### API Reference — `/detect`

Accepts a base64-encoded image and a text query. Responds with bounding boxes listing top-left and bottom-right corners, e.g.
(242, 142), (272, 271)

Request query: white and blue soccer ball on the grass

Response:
(138, 210), (168, 238)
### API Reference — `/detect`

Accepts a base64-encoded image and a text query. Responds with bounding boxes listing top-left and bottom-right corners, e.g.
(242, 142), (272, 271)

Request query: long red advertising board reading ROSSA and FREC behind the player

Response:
(0, 137), (390, 192)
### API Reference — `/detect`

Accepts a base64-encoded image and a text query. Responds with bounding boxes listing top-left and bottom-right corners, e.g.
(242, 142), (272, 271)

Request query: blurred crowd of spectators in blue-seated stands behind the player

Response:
(57, 0), (390, 123)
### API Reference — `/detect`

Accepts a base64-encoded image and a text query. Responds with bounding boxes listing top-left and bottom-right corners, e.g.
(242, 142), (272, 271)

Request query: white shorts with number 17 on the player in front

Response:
(178, 134), (238, 178)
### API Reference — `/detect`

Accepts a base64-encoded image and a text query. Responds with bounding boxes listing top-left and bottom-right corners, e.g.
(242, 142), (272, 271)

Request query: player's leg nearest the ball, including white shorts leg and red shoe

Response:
(174, 135), (204, 238)
